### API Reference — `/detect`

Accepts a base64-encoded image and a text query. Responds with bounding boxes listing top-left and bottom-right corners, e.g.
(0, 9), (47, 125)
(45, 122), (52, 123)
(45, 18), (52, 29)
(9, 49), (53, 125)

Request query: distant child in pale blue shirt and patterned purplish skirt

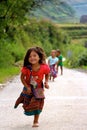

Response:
(48, 50), (58, 81)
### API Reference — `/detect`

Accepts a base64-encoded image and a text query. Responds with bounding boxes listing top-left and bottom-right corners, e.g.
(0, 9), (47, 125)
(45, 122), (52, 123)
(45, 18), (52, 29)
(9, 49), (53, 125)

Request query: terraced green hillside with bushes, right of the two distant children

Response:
(56, 24), (87, 70)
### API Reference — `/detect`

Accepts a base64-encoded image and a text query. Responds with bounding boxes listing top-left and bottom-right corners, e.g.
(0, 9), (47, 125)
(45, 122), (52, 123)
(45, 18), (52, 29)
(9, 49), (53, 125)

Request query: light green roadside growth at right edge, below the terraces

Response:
(64, 39), (87, 69)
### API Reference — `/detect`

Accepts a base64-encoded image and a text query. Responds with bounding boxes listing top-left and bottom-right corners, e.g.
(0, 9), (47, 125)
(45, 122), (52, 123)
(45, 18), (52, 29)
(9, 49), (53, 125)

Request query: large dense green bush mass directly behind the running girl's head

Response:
(21, 19), (69, 55)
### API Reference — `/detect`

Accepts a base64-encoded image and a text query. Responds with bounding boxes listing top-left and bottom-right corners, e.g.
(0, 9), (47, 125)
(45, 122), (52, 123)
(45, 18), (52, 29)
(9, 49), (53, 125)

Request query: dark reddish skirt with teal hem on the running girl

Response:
(14, 87), (44, 116)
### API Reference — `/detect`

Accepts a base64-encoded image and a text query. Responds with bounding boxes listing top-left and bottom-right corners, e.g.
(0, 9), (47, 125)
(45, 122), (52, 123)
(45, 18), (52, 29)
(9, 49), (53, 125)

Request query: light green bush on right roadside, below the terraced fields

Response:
(65, 44), (87, 68)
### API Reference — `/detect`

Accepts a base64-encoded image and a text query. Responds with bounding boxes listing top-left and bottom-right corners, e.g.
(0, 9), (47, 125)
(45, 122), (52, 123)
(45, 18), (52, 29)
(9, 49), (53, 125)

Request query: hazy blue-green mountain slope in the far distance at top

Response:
(31, 0), (87, 23)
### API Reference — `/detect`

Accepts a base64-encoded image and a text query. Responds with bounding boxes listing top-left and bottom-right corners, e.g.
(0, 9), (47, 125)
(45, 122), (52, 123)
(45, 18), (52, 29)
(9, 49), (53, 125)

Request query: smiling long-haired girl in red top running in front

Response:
(14, 47), (50, 127)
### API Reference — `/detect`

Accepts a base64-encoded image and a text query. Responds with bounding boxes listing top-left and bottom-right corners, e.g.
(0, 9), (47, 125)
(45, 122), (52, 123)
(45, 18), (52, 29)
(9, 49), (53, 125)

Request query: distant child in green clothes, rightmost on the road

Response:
(56, 49), (63, 75)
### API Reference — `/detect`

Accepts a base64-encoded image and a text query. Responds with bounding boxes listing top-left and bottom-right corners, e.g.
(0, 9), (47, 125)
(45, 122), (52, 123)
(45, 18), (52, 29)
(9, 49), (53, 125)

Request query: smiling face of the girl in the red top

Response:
(29, 51), (40, 65)
